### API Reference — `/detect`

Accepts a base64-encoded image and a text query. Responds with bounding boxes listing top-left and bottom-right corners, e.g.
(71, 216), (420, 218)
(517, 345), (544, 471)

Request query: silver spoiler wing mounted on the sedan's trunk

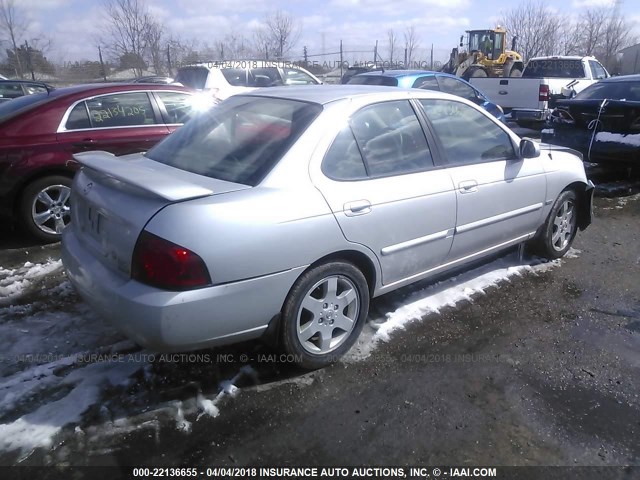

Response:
(73, 150), (213, 202)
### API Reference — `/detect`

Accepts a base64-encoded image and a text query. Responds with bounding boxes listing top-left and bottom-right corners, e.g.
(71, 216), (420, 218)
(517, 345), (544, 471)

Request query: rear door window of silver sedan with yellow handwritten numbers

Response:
(350, 100), (433, 177)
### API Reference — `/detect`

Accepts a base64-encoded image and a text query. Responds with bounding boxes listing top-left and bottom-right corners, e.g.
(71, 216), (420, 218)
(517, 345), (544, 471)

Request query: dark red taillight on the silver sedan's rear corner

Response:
(131, 231), (211, 290)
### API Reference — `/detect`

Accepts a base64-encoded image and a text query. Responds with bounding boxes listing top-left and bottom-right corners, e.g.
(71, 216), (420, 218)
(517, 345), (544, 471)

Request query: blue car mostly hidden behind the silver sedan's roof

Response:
(347, 70), (505, 122)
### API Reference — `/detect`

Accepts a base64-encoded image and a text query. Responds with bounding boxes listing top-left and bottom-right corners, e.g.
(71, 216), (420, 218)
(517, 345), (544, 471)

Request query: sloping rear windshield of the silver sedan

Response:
(146, 95), (322, 186)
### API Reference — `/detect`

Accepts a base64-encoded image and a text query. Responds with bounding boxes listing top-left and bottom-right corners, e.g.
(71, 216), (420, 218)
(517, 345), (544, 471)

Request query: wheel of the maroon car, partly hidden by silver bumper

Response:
(19, 175), (72, 243)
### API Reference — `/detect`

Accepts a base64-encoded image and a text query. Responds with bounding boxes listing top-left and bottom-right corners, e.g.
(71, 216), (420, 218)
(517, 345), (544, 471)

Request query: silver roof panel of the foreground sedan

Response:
(240, 85), (453, 105)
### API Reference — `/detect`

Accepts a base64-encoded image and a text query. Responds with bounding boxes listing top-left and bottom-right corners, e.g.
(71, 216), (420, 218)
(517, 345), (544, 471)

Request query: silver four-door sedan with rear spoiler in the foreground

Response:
(63, 86), (593, 368)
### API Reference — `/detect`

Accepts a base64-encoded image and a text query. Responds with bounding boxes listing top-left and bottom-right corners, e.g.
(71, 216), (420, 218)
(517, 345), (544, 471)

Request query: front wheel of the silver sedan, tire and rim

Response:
(531, 190), (579, 260)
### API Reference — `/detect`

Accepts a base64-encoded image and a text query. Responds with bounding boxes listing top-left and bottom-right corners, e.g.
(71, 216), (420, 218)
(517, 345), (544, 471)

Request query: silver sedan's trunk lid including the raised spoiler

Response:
(71, 151), (251, 276)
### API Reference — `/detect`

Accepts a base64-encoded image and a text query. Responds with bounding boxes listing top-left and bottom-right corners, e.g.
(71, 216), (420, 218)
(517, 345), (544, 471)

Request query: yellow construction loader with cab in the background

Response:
(442, 27), (524, 80)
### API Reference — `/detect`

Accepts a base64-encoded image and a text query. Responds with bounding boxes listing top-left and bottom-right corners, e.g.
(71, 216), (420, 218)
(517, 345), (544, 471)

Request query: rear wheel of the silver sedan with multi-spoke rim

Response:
(281, 261), (369, 369)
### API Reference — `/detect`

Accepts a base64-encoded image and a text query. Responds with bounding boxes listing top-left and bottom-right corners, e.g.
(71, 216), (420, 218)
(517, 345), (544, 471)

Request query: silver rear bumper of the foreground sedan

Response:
(62, 227), (305, 352)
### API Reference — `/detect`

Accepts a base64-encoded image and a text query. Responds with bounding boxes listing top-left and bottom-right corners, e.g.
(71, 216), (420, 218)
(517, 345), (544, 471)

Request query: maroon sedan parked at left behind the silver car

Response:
(0, 84), (201, 241)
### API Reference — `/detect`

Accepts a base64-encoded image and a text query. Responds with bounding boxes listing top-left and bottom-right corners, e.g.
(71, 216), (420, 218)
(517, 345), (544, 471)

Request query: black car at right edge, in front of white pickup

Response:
(542, 75), (640, 165)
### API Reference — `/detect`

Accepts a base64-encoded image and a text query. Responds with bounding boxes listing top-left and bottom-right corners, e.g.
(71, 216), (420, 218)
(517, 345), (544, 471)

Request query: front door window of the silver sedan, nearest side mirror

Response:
(420, 100), (516, 165)
